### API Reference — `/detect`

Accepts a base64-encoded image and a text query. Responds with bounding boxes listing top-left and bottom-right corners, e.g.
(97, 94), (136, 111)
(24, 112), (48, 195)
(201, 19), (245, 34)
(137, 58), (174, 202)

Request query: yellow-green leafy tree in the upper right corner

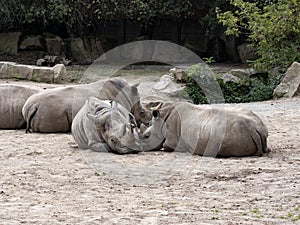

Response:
(217, 0), (300, 70)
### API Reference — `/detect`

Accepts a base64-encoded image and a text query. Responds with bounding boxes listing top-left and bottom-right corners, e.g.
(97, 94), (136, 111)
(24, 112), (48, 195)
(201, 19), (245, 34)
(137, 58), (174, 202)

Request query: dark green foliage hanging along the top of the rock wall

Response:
(0, 0), (193, 35)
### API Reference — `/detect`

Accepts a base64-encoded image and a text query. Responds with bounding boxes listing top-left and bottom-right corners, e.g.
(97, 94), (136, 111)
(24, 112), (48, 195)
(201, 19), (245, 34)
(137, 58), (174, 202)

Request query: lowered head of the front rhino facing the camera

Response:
(87, 101), (141, 154)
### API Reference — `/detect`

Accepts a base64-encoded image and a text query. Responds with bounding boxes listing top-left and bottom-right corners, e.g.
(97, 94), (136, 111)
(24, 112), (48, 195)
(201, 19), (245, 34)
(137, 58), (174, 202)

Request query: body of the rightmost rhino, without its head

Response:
(166, 103), (267, 157)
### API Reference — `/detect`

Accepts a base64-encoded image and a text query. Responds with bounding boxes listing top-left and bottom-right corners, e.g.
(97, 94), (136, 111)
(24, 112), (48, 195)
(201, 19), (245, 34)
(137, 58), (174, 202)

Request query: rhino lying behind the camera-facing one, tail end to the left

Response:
(22, 78), (151, 133)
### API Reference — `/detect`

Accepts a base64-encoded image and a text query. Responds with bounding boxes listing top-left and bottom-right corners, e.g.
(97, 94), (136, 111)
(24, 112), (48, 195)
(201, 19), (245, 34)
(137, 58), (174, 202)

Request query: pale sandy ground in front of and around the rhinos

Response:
(0, 76), (300, 225)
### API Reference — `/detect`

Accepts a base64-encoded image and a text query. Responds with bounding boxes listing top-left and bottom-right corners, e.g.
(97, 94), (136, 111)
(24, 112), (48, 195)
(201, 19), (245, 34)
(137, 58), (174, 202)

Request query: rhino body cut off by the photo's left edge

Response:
(0, 84), (40, 129)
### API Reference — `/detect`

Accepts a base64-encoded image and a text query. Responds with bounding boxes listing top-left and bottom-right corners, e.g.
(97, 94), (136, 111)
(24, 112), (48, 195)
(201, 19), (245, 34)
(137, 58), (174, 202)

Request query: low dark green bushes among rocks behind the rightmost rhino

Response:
(185, 64), (281, 104)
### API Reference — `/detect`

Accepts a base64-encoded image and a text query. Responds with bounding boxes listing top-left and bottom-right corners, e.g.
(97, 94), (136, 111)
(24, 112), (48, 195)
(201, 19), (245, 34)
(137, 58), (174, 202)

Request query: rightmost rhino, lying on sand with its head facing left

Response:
(140, 102), (268, 157)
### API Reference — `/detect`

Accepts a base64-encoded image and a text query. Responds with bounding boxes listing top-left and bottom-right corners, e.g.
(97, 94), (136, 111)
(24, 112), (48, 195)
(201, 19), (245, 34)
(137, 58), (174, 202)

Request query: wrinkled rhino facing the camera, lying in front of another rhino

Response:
(71, 97), (140, 154)
